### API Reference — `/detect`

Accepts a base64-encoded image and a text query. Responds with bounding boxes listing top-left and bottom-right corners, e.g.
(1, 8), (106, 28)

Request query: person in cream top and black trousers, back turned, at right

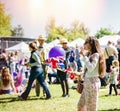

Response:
(104, 41), (118, 73)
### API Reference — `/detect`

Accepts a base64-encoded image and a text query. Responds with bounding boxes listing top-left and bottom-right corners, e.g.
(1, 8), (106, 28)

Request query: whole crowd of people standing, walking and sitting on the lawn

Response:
(0, 36), (120, 111)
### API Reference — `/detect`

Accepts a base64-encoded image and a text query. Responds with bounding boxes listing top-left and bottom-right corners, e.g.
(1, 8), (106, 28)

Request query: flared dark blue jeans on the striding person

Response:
(21, 67), (51, 99)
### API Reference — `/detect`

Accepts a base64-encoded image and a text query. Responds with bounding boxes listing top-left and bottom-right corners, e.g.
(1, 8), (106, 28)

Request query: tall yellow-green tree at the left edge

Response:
(0, 2), (12, 36)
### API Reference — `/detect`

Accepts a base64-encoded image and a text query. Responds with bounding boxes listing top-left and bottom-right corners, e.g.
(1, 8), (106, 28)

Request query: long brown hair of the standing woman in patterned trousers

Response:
(85, 36), (106, 76)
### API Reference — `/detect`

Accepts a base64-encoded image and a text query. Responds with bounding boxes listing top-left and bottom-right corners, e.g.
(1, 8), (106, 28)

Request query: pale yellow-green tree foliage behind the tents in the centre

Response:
(46, 18), (89, 42)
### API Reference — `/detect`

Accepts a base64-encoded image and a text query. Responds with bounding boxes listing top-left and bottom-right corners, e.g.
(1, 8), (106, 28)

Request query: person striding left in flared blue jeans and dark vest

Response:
(19, 42), (51, 100)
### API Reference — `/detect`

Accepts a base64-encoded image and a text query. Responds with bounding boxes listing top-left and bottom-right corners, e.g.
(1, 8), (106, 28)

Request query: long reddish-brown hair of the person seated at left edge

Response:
(1, 67), (12, 87)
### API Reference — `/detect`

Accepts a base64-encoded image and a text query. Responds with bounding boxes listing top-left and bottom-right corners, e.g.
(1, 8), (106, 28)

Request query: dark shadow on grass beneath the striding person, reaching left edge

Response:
(0, 97), (46, 103)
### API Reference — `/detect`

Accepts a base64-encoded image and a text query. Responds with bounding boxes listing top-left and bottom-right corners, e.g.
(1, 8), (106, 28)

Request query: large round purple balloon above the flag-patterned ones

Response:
(49, 46), (65, 58)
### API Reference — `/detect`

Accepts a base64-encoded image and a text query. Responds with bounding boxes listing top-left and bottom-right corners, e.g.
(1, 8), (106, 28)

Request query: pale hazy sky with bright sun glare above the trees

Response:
(1, 0), (120, 38)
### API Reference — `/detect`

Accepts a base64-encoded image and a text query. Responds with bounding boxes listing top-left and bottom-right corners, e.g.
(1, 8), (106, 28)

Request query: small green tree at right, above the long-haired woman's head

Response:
(95, 28), (116, 39)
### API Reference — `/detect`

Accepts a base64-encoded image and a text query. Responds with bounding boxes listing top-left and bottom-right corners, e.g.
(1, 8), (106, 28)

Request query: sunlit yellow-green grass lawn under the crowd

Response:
(0, 84), (120, 111)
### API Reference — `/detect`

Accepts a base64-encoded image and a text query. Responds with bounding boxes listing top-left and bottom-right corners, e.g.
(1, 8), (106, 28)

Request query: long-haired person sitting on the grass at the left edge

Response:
(0, 67), (16, 94)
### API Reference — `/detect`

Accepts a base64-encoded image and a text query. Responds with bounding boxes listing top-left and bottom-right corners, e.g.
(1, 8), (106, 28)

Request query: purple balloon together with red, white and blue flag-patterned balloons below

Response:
(44, 46), (75, 79)
